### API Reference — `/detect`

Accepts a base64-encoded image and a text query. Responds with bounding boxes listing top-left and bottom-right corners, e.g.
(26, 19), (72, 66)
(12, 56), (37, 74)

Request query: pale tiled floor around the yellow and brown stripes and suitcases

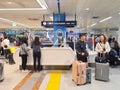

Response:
(0, 60), (120, 90)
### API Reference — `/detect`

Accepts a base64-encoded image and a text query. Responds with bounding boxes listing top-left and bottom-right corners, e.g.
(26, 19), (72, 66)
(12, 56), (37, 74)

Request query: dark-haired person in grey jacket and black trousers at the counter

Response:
(19, 38), (29, 71)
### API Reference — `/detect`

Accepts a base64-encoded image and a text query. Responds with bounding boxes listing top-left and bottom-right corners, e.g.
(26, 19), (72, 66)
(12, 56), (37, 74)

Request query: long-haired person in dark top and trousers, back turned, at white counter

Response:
(31, 37), (42, 72)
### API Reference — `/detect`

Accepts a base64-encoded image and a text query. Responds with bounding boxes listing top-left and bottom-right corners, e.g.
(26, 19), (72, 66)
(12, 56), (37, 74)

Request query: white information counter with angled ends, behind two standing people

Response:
(13, 47), (75, 66)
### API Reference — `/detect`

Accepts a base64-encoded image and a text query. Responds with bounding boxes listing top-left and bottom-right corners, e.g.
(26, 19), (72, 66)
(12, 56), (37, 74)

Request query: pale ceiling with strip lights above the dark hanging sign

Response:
(0, 0), (120, 28)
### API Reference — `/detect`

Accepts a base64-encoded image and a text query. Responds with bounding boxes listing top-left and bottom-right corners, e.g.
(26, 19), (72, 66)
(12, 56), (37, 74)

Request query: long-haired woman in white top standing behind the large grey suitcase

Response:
(95, 34), (111, 62)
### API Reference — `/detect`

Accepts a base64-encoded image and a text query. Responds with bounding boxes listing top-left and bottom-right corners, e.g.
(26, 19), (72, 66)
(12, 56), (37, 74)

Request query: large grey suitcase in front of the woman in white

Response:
(95, 63), (109, 81)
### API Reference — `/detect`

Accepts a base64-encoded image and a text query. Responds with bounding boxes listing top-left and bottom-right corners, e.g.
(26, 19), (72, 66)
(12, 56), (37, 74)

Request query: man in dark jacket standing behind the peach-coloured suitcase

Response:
(76, 34), (88, 62)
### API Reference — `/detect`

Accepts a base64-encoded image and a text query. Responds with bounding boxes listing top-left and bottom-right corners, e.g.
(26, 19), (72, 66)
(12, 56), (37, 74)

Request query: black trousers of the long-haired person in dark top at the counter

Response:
(33, 52), (41, 71)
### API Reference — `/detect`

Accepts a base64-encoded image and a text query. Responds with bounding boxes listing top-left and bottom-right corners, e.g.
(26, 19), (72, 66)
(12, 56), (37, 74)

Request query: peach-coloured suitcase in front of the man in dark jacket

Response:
(72, 61), (86, 85)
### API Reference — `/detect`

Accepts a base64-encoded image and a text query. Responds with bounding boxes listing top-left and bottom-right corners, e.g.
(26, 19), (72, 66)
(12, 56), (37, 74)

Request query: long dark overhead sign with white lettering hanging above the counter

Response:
(41, 21), (77, 28)
